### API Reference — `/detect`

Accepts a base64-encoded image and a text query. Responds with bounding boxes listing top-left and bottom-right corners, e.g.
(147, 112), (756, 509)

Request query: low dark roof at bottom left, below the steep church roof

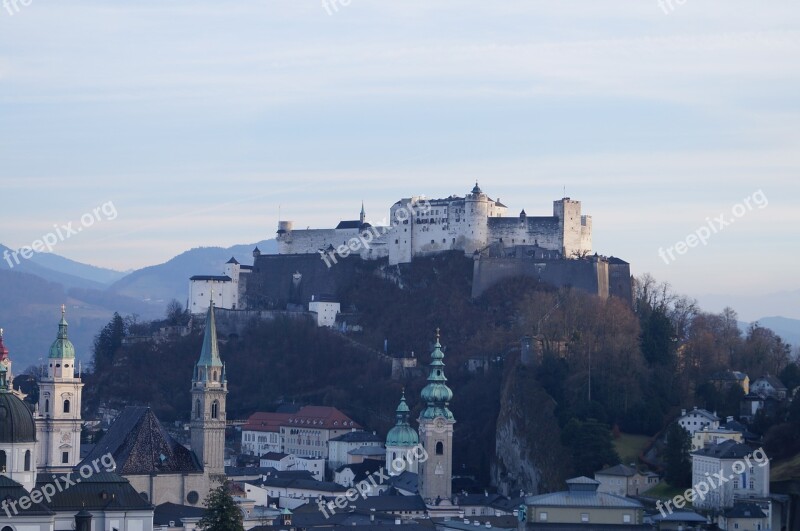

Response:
(36, 472), (153, 512)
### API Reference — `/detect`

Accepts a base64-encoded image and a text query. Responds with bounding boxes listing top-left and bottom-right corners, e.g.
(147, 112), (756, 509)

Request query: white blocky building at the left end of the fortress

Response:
(189, 255), (253, 313)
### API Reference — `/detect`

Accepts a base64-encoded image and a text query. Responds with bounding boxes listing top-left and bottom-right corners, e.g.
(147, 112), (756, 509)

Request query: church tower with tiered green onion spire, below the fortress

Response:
(419, 330), (456, 505)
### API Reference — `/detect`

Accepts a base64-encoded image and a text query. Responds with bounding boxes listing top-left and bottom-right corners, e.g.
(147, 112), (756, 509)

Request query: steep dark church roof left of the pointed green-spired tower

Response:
(81, 406), (203, 475)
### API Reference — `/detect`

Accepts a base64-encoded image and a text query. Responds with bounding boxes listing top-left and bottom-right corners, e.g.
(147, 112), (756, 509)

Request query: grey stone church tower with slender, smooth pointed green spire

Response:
(191, 300), (228, 478)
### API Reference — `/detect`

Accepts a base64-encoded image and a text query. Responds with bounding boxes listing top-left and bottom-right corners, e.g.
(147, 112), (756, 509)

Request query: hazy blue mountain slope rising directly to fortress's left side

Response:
(109, 240), (278, 308)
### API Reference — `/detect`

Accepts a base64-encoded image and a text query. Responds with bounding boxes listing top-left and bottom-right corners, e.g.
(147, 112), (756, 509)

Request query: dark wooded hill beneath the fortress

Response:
(84, 255), (800, 490)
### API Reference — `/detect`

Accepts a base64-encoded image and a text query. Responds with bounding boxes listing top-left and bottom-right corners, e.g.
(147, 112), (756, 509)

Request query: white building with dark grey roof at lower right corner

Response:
(692, 440), (770, 515)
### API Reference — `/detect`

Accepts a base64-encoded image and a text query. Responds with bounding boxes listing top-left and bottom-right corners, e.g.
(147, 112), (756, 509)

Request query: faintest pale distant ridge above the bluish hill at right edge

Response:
(697, 289), (800, 322)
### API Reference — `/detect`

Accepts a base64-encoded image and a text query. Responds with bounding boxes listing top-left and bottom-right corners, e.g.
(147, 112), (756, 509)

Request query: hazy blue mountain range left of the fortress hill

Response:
(0, 240), (277, 374)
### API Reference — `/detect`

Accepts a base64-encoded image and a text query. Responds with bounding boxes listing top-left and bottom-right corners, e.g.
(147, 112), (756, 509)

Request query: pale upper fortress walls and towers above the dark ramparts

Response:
(277, 183), (592, 265)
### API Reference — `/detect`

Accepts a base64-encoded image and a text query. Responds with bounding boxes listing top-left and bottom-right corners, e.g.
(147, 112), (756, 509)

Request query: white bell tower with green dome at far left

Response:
(35, 305), (83, 473)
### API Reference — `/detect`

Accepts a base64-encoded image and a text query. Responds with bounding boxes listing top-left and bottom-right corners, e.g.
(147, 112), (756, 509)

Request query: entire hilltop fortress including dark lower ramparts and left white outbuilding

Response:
(190, 183), (632, 313)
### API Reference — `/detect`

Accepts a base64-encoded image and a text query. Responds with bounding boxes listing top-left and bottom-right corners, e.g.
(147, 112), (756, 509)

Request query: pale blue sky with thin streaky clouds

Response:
(0, 0), (800, 316)
